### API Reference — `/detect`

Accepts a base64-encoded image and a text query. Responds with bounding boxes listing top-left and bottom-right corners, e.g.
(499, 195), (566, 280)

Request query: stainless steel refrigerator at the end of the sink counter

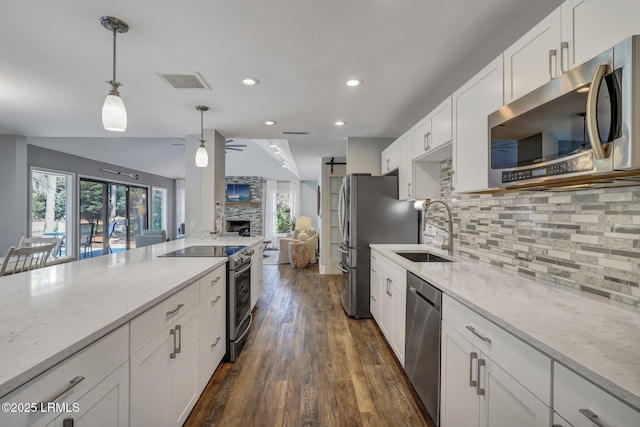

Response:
(338, 174), (420, 319)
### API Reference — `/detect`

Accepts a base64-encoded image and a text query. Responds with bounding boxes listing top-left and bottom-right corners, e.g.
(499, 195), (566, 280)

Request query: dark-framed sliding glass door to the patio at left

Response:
(79, 178), (148, 259)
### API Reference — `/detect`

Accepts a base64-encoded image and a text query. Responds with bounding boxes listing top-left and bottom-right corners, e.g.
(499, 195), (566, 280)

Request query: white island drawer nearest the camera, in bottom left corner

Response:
(0, 325), (129, 427)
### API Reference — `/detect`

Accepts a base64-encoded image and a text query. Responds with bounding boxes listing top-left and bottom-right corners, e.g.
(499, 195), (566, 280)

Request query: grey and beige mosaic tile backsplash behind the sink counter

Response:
(425, 160), (640, 306)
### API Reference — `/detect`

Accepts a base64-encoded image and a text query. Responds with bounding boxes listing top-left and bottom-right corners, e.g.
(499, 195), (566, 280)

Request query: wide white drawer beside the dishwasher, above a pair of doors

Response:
(442, 294), (551, 406)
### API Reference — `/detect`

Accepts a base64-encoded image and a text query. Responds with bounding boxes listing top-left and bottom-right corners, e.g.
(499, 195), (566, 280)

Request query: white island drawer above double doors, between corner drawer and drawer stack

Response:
(130, 282), (199, 355)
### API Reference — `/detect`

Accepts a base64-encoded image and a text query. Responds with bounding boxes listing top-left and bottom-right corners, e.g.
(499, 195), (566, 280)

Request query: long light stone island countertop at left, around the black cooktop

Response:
(0, 236), (262, 396)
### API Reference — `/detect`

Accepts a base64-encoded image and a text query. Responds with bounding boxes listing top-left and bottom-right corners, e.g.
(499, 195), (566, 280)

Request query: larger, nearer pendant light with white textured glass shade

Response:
(100, 16), (129, 132)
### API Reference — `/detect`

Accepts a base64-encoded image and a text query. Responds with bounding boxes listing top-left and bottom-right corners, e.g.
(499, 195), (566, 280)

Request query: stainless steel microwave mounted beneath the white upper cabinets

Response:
(489, 36), (640, 189)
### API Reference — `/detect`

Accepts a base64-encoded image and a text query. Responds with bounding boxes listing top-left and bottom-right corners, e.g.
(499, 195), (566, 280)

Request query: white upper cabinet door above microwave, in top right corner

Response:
(562, 0), (640, 68)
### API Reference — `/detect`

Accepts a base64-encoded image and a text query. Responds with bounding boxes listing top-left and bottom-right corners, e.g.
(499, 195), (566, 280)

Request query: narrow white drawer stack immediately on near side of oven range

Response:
(199, 265), (227, 390)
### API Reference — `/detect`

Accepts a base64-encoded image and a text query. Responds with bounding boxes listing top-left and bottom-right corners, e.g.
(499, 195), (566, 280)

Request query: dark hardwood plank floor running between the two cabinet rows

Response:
(185, 264), (433, 427)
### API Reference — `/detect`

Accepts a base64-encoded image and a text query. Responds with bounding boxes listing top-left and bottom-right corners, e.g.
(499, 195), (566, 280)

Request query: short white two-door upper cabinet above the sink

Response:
(412, 96), (453, 159)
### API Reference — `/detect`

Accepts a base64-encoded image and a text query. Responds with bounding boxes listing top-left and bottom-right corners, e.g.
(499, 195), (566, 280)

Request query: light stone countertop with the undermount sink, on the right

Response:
(370, 244), (640, 410)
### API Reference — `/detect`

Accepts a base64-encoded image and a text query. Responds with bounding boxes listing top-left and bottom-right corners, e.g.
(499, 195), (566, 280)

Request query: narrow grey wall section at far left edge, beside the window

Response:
(0, 135), (29, 252)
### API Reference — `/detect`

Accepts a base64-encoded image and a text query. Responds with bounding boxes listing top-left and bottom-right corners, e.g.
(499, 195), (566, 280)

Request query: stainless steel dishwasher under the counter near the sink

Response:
(404, 273), (442, 425)
